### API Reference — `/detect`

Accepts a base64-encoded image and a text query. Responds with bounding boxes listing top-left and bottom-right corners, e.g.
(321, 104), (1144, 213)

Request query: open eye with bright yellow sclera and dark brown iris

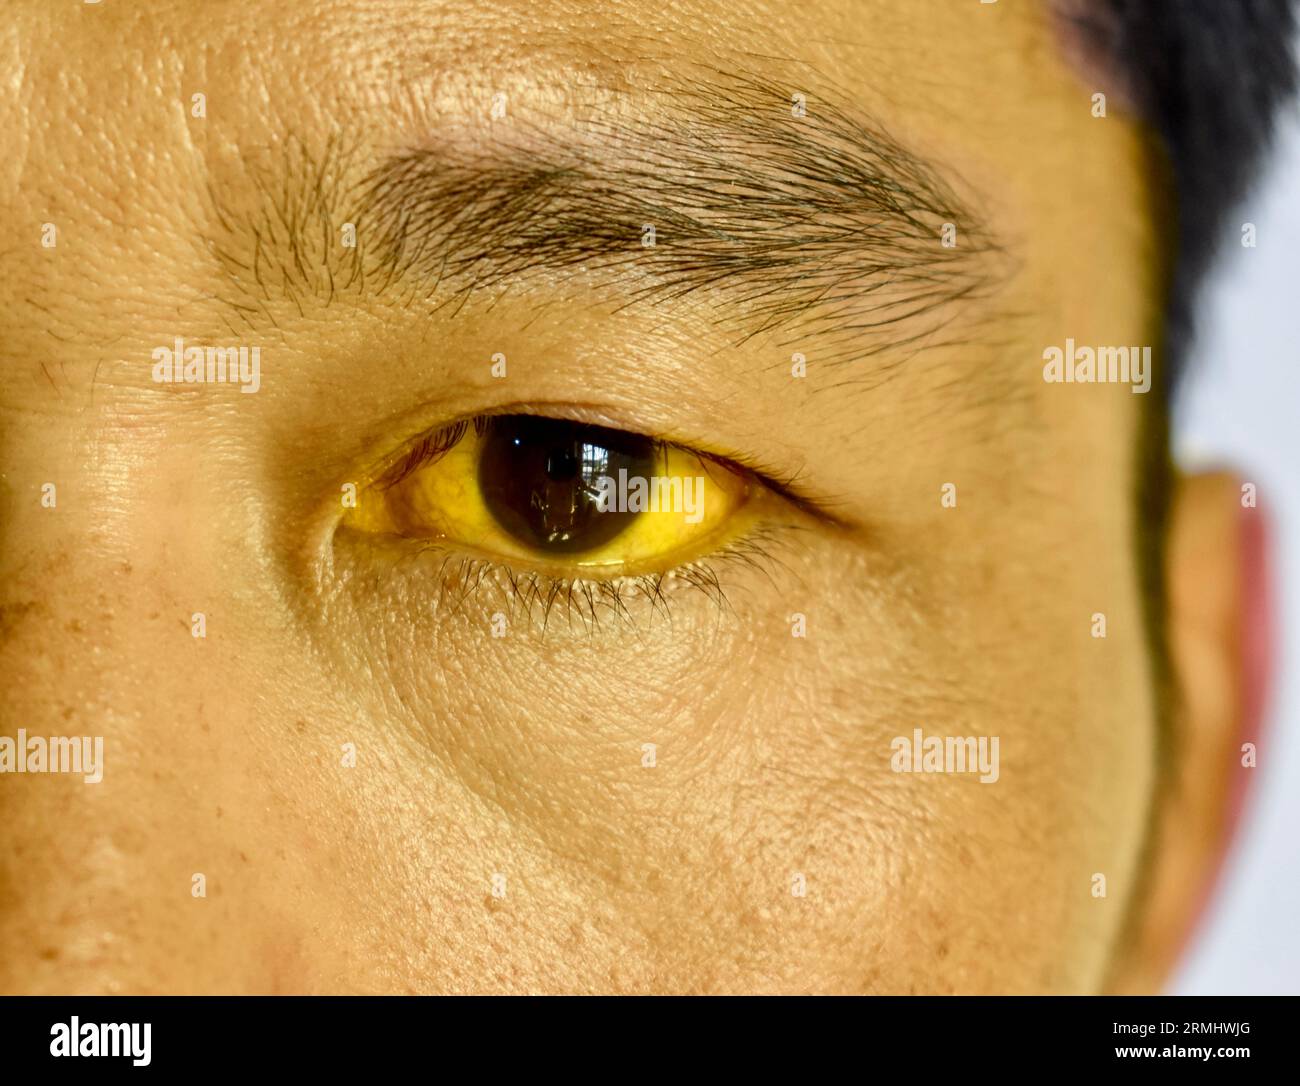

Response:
(345, 415), (758, 576)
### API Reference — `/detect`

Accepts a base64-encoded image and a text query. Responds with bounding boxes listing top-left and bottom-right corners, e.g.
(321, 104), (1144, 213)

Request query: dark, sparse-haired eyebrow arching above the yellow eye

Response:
(209, 73), (998, 360)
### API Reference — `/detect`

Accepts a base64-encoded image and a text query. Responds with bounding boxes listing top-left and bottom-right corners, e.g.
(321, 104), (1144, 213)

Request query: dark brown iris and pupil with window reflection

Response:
(478, 415), (655, 554)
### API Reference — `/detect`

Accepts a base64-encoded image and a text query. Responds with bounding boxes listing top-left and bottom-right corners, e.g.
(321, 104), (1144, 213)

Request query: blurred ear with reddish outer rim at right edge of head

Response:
(1112, 473), (1271, 992)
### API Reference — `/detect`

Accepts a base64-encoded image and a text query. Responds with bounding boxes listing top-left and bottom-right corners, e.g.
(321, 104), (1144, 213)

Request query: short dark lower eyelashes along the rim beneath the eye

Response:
(395, 524), (801, 633)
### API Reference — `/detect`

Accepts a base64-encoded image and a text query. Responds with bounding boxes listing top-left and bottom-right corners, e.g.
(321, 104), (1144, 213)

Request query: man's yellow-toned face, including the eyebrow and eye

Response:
(0, 0), (1235, 992)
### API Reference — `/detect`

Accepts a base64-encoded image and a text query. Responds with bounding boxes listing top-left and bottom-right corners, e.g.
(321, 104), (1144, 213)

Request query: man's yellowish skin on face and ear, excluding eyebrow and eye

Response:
(0, 0), (1239, 992)
